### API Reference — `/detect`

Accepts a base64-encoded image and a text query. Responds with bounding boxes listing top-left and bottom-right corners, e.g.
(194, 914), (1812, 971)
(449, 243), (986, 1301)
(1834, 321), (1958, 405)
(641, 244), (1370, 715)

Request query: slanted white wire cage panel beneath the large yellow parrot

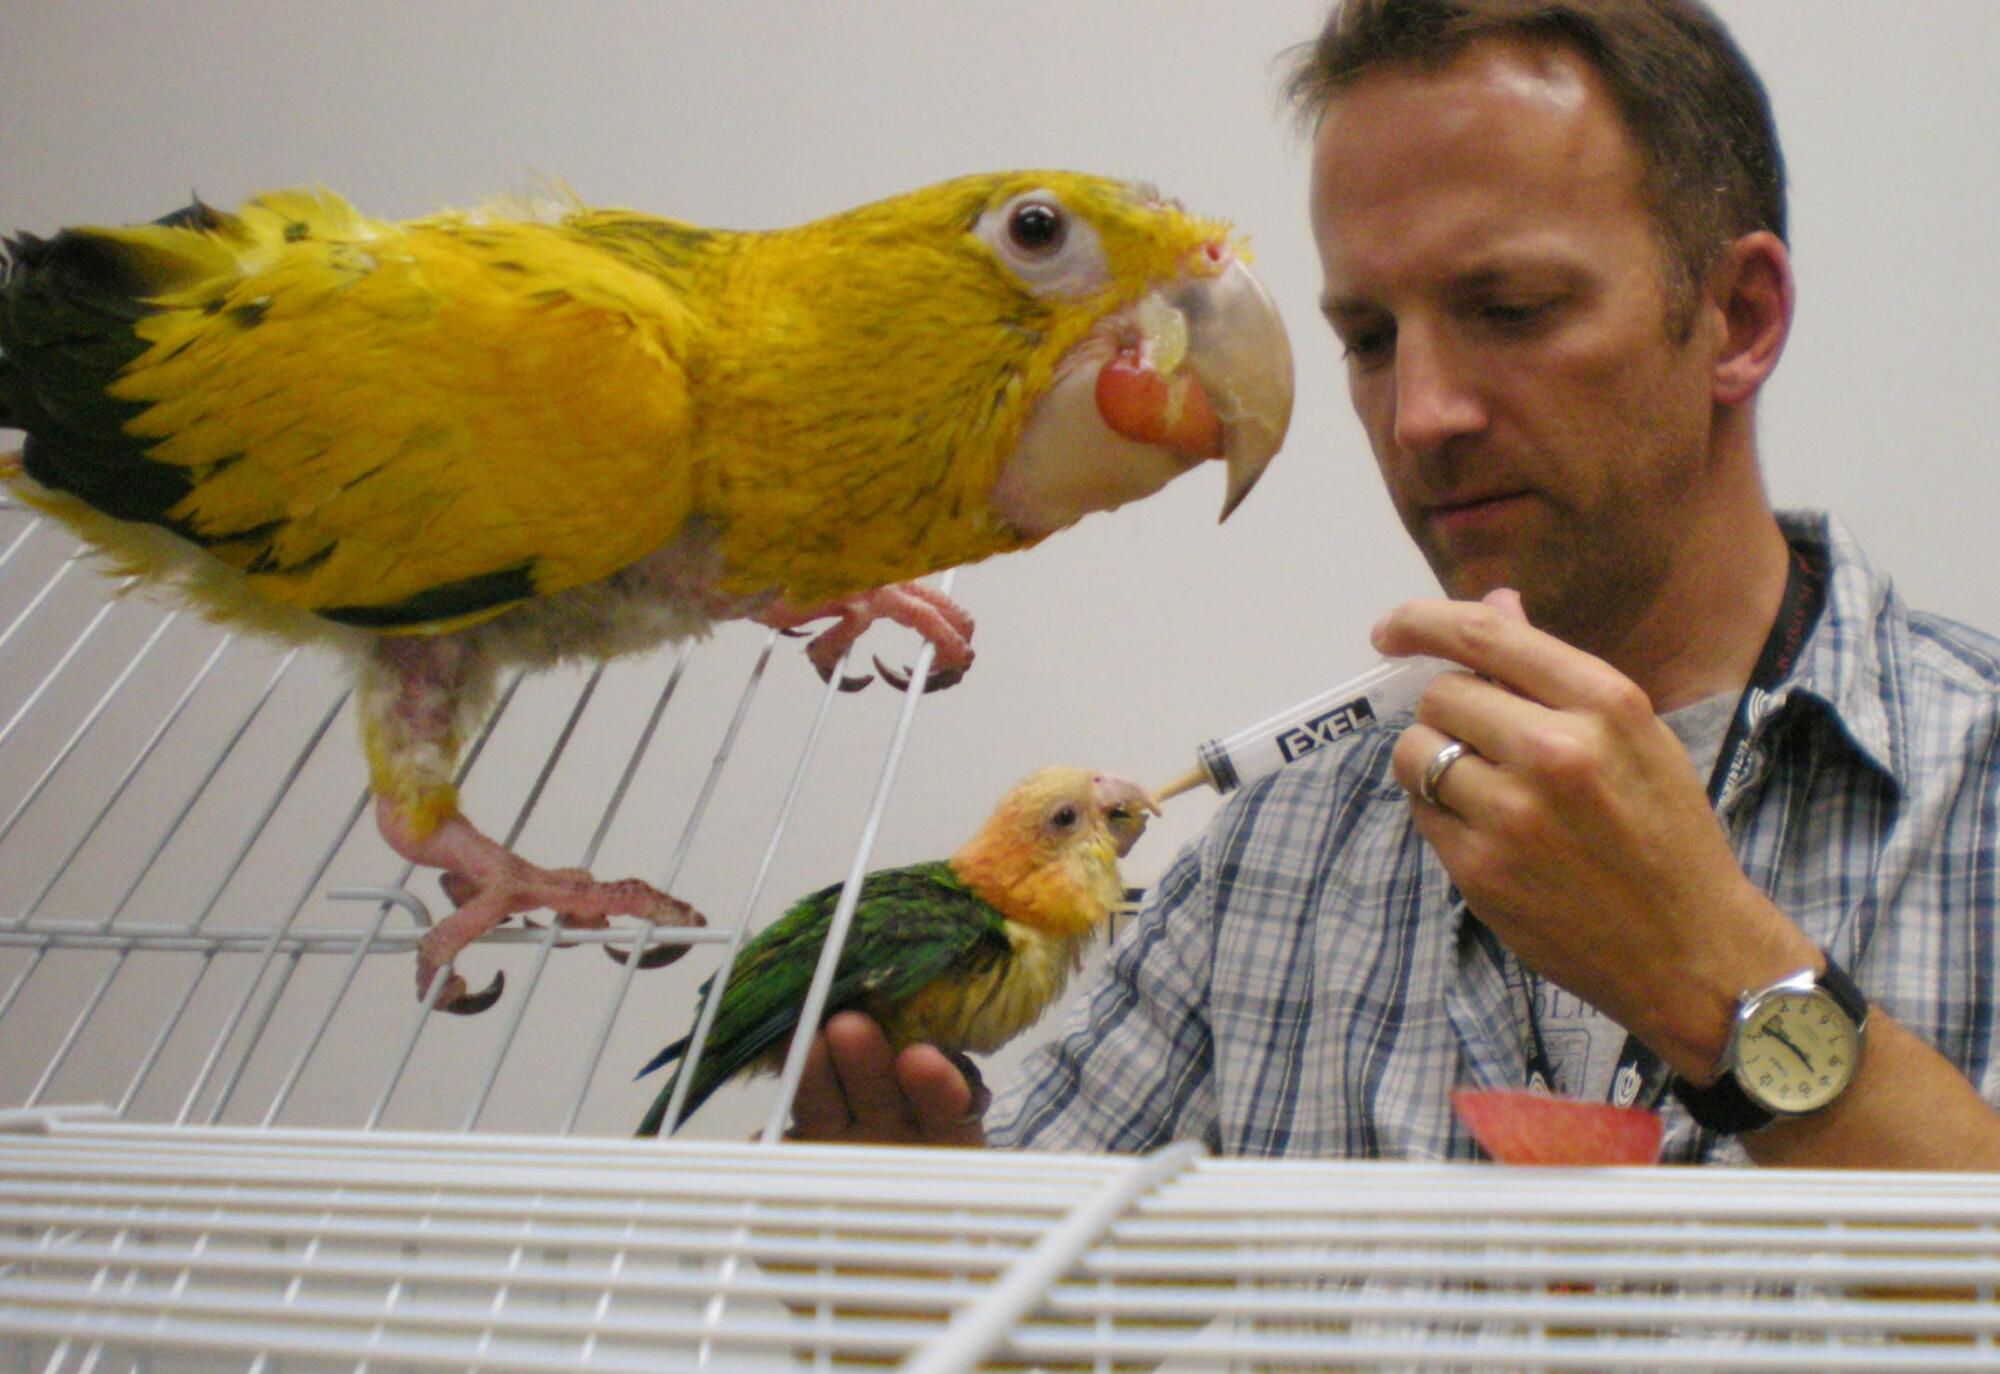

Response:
(0, 494), (976, 1134)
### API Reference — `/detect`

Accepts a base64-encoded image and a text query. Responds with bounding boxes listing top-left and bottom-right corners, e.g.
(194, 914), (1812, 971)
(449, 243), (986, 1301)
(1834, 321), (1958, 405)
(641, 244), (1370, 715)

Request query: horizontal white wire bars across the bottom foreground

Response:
(0, 1116), (2000, 1370)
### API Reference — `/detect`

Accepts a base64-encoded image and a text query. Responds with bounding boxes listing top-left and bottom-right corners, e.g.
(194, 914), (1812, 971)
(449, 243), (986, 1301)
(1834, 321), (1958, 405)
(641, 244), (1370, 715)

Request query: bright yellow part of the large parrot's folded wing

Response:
(112, 194), (692, 630)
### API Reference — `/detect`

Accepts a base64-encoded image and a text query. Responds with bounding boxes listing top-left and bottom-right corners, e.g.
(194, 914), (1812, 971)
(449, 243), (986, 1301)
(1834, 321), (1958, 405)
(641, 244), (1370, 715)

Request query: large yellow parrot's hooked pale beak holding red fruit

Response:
(1096, 242), (1292, 520)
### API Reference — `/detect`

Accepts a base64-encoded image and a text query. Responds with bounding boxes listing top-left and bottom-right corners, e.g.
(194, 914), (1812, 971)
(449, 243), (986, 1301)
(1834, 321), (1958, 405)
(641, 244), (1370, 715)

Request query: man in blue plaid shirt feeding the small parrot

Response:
(776, 0), (2000, 1170)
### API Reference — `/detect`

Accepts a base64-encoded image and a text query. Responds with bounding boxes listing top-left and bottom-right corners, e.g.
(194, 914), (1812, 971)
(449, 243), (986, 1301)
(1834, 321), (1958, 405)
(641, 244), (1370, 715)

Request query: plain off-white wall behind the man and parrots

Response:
(0, 0), (2000, 1134)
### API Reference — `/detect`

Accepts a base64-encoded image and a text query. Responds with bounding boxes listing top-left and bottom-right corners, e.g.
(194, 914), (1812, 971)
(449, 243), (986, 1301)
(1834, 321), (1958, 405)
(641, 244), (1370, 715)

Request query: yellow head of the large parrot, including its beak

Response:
(748, 170), (1292, 552)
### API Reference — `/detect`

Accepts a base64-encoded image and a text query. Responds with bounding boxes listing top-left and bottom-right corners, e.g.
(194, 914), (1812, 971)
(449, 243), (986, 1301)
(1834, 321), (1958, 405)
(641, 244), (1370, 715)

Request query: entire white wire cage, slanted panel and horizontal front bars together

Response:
(0, 490), (2000, 1372)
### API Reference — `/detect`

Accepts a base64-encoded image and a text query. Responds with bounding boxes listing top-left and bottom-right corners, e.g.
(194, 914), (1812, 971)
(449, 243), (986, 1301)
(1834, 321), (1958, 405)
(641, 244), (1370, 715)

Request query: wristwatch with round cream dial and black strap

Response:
(1674, 950), (1868, 1136)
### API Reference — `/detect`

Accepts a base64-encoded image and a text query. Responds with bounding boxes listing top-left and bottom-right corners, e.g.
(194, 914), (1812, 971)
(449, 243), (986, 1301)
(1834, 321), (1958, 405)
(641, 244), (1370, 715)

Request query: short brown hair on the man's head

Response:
(1286, 0), (1786, 334)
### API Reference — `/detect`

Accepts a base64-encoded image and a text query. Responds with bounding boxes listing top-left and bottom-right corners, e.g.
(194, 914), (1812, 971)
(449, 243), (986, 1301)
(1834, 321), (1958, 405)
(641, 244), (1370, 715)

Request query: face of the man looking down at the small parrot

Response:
(1312, 40), (1714, 646)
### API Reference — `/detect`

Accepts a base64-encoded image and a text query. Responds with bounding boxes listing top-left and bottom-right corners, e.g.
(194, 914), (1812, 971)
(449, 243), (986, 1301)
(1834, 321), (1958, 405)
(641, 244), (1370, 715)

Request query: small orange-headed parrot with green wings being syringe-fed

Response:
(638, 768), (1158, 1136)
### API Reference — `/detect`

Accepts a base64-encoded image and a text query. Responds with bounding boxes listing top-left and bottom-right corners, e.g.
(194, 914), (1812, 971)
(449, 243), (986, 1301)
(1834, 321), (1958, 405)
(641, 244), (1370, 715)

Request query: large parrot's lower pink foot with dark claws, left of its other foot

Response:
(378, 800), (708, 1016)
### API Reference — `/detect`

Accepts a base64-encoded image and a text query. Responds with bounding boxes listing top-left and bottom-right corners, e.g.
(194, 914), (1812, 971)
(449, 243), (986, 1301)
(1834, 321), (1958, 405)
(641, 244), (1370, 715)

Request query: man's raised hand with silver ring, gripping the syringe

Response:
(1374, 590), (1818, 1080)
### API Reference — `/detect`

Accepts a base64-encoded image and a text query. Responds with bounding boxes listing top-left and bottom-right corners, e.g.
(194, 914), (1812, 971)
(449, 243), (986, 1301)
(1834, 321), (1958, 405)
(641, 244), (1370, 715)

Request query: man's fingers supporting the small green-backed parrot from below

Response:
(786, 1012), (990, 1146)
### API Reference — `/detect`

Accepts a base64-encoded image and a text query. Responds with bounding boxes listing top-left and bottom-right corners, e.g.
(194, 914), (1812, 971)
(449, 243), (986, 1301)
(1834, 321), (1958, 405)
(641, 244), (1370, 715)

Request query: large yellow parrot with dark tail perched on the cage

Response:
(0, 172), (1292, 1010)
